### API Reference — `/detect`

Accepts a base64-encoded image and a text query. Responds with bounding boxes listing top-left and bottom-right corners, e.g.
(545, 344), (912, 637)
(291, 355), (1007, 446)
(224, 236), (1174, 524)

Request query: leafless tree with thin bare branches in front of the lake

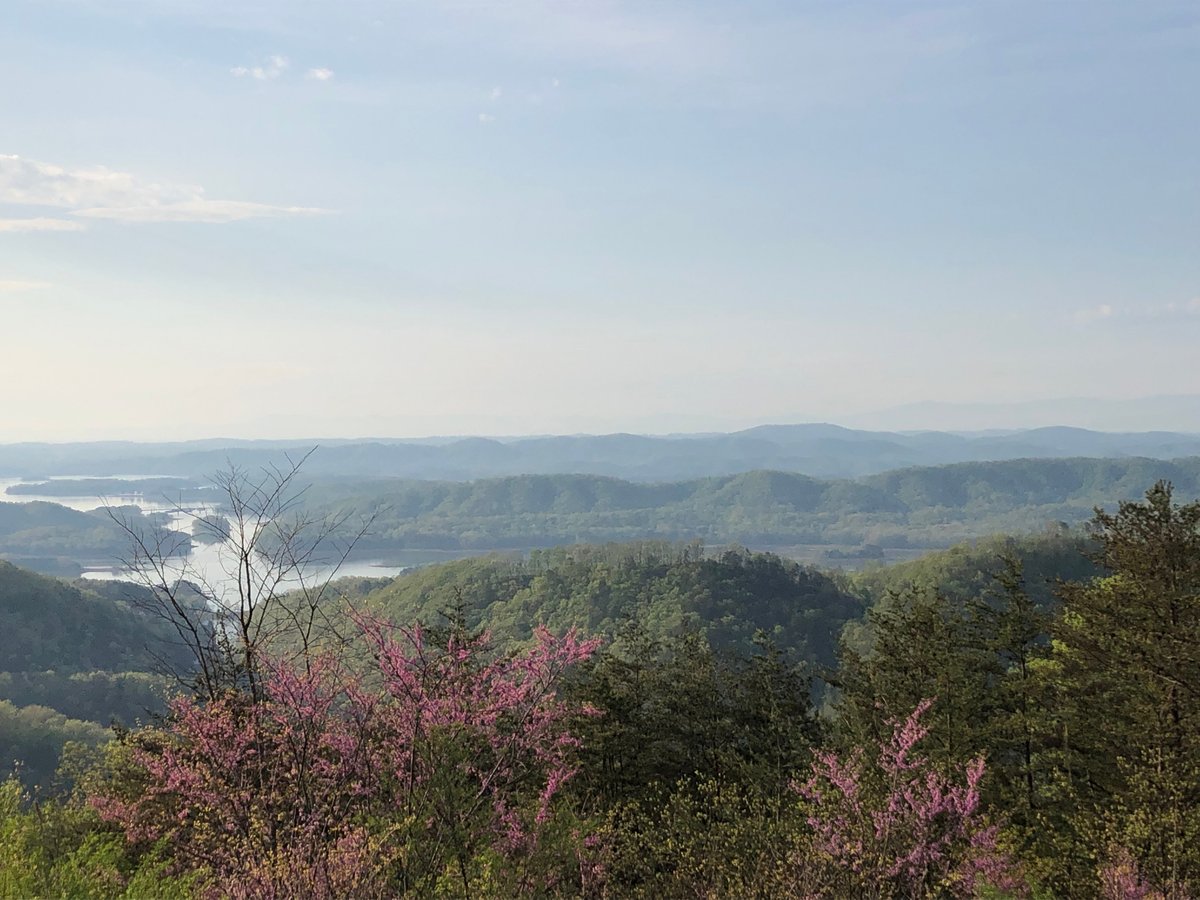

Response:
(107, 448), (374, 700)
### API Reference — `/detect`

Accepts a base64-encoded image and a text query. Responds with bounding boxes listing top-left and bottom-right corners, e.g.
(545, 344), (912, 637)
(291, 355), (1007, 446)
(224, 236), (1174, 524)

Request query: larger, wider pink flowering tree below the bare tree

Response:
(87, 617), (596, 898)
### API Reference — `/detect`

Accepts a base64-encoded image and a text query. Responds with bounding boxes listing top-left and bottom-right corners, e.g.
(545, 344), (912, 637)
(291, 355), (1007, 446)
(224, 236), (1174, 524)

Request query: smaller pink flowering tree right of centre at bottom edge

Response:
(794, 700), (1024, 898)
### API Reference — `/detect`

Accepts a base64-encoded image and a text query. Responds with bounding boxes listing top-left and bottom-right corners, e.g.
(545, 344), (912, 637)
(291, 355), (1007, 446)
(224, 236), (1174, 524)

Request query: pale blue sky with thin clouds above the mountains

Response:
(0, 0), (1200, 442)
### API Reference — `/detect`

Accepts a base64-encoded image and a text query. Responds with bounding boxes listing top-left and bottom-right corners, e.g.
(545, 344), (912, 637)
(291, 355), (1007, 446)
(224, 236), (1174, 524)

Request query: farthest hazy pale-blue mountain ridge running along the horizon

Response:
(7, 424), (1200, 481)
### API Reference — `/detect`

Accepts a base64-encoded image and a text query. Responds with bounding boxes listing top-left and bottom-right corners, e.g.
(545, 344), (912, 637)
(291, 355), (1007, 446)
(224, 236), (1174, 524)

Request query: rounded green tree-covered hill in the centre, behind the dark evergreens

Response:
(366, 544), (862, 665)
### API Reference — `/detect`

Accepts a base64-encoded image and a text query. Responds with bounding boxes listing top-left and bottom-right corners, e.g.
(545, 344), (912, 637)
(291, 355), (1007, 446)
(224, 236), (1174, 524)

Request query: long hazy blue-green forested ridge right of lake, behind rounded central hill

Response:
(311, 457), (1200, 552)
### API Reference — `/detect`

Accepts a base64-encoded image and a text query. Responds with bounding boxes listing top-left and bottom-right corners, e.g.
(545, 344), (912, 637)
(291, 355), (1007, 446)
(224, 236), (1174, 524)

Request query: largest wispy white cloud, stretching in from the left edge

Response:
(0, 155), (328, 230)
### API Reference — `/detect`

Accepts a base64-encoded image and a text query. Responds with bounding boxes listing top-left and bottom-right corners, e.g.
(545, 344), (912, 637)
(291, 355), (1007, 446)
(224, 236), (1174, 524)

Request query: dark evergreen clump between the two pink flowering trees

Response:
(571, 624), (820, 806)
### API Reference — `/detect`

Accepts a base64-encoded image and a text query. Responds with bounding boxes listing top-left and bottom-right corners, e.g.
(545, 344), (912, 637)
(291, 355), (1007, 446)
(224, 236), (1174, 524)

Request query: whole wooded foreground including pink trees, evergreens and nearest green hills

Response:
(0, 482), (1200, 899)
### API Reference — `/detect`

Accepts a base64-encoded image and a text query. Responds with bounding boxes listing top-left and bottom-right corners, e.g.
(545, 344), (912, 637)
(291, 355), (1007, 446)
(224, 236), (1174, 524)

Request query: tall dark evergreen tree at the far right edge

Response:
(1052, 482), (1200, 894)
